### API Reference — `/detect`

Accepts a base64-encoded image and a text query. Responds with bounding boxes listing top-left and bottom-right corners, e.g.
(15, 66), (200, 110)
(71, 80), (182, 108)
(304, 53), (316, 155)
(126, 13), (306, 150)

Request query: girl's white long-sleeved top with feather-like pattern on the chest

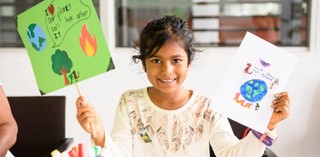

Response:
(105, 88), (265, 157)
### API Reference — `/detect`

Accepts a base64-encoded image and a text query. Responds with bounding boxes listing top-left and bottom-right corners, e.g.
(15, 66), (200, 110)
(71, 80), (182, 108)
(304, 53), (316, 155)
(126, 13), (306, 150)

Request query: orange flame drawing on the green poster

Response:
(79, 24), (97, 57)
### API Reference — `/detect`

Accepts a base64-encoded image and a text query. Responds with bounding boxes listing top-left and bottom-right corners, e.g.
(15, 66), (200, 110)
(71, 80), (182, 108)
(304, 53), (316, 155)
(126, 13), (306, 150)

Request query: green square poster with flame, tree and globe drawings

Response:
(16, 0), (114, 95)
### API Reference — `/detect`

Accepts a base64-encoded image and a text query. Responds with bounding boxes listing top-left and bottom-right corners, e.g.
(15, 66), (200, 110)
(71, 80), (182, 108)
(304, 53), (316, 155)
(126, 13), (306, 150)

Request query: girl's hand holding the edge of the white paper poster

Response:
(268, 92), (290, 130)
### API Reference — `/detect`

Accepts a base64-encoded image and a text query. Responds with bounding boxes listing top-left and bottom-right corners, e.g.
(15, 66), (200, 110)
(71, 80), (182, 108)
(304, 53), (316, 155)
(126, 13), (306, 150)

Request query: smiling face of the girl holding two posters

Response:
(144, 42), (189, 93)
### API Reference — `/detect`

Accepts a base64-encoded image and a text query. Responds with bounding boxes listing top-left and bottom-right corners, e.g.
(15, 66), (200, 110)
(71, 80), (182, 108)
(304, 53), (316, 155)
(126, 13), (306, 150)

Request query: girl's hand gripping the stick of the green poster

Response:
(76, 96), (104, 147)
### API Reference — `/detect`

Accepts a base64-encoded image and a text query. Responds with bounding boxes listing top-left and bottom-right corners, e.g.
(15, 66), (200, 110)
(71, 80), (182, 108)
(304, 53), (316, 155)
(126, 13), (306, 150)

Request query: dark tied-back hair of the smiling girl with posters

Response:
(132, 16), (198, 66)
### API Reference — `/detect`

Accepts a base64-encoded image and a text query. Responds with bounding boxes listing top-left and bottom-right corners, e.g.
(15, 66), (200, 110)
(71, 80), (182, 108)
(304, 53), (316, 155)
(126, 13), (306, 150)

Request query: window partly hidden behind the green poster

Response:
(0, 0), (99, 48)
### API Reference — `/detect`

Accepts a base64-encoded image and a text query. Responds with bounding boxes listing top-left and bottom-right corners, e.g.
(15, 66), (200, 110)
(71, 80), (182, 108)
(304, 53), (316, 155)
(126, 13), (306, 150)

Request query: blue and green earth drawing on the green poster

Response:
(27, 23), (47, 51)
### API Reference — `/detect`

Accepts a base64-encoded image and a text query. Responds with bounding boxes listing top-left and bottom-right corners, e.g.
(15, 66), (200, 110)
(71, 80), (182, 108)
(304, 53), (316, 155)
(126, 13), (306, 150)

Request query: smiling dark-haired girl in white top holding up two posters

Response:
(76, 16), (290, 157)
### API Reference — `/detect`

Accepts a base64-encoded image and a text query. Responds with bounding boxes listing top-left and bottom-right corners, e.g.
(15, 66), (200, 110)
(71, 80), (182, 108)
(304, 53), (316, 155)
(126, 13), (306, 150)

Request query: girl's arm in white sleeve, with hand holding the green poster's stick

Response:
(76, 97), (132, 157)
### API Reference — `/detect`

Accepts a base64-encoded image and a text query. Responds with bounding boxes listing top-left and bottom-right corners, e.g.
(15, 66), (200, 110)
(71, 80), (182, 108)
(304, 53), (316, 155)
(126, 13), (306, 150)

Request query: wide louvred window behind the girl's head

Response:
(115, 0), (310, 47)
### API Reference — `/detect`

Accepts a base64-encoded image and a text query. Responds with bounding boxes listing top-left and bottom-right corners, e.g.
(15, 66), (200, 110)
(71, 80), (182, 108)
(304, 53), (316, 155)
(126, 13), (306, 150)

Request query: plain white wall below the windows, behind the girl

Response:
(0, 49), (320, 157)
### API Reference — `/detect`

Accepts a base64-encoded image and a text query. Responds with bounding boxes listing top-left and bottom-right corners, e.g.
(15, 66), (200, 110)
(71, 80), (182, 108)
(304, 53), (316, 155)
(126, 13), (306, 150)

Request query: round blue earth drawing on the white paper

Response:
(240, 79), (268, 102)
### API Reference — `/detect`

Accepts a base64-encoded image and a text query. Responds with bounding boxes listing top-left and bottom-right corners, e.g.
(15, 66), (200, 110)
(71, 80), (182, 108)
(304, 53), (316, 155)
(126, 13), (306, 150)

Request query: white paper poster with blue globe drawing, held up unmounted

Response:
(213, 32), (298, 133)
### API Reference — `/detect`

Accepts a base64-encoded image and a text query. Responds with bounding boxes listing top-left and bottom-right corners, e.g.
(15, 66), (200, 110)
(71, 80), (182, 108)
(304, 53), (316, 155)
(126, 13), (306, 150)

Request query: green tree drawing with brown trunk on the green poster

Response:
(51, 49), (72, 85)
